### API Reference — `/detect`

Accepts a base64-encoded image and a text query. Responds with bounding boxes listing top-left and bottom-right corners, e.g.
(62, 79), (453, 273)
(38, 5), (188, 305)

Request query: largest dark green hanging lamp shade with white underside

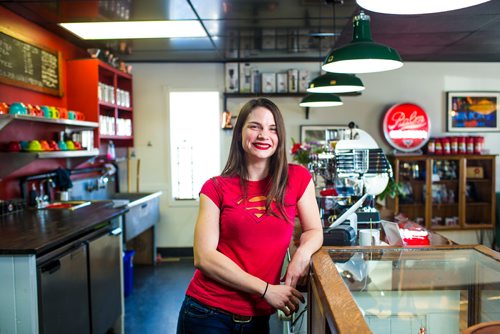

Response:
(322, 12), (403, 73)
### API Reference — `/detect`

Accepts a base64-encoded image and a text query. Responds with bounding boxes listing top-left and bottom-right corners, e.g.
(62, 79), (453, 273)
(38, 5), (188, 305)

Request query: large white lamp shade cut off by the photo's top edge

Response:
(356, 0), (490, 15)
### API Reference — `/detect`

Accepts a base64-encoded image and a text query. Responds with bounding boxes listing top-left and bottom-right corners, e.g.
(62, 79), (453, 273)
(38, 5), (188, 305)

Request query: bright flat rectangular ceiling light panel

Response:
(59, 20), (207, 39)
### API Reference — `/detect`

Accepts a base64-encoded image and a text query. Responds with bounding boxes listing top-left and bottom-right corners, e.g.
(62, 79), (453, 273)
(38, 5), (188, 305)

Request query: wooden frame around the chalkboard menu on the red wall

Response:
(0, 26), (63, 97)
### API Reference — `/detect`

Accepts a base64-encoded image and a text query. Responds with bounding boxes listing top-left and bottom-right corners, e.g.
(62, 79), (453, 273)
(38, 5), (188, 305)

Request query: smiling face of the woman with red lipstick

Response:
(241, 107), (278, 160)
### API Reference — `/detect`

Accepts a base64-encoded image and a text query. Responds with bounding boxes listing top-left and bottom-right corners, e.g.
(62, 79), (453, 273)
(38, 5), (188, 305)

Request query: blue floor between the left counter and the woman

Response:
(125, 258), (283, 334)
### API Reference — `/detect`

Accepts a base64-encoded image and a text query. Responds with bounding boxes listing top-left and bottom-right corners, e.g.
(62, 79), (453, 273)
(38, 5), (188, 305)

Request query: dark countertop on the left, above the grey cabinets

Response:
(0, 201), (128, 255)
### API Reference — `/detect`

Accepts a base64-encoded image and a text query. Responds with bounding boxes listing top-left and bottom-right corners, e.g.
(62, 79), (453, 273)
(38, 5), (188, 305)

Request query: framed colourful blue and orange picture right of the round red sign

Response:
(446, 92), (500, 132)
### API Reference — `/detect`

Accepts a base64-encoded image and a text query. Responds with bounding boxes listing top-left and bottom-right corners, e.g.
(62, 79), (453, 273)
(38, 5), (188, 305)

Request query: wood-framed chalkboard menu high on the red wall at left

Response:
(0, 30), (62, 96)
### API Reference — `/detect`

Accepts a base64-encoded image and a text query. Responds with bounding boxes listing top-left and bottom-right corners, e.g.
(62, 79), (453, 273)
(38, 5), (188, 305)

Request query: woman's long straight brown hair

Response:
(221, 98), (290, 221)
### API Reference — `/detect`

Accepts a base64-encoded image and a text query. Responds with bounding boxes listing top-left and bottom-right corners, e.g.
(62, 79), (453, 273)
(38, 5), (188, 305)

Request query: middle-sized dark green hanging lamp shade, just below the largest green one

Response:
(307, 73), (365, 93)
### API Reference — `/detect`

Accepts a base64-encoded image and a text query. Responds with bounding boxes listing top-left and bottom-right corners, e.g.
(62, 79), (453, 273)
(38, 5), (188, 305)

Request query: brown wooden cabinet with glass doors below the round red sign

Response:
(387, 154), (496, 230)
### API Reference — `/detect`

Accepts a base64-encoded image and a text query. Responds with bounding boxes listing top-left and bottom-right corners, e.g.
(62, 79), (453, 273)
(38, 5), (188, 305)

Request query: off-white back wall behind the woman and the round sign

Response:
(132, 63), (500, 247)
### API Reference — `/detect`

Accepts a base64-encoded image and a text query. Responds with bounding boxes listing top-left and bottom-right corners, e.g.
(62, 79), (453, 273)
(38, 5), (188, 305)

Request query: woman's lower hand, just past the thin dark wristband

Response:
(264, 284), (305, 316)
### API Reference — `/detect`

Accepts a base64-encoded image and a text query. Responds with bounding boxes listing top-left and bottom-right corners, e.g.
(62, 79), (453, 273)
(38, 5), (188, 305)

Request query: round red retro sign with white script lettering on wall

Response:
(383, 103), (431, 152)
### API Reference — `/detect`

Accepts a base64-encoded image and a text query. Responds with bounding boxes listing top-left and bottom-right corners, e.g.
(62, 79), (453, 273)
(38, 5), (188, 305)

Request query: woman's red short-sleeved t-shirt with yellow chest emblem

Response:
(186, 164), (311, 316)
